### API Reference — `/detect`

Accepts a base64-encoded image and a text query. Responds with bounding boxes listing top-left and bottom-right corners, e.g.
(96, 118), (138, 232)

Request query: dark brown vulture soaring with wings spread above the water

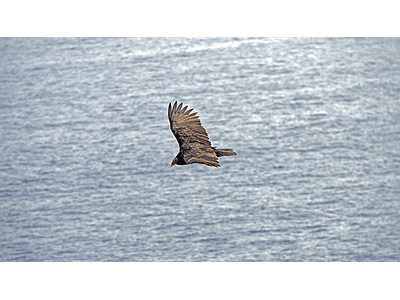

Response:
(168, 101), (236, 168)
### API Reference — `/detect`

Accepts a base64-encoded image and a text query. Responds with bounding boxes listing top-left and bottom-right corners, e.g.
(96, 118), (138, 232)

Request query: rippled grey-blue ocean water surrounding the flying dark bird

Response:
(0, 38), (400, 261)
